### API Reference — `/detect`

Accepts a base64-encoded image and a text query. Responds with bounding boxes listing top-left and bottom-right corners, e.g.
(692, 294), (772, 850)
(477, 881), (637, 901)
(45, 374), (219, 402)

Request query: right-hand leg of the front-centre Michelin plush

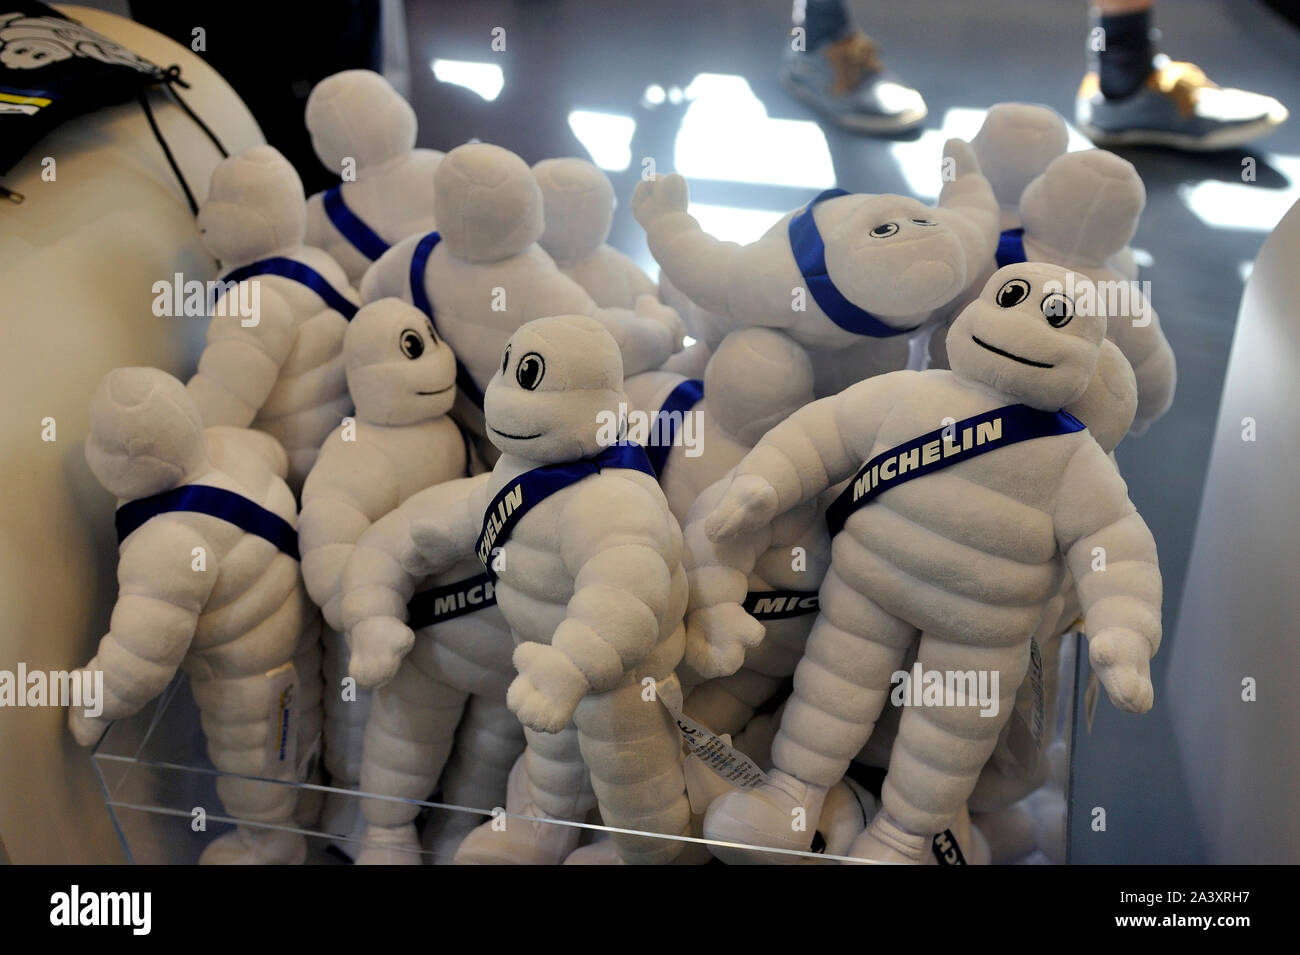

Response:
(573, 674), (692, 865)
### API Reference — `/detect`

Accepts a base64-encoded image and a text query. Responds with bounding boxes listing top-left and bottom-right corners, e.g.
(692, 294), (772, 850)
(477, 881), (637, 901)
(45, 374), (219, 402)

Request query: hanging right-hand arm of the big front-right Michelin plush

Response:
(1053, 437), (1161, 713)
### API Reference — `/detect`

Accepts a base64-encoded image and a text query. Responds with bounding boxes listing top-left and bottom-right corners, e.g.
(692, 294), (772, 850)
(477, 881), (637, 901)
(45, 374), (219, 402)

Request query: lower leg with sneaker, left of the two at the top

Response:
(780, 0), (926, 133)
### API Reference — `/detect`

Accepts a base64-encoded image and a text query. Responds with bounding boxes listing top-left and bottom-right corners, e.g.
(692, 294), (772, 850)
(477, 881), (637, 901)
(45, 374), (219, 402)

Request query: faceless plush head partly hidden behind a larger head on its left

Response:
(533, 159), (614, 264)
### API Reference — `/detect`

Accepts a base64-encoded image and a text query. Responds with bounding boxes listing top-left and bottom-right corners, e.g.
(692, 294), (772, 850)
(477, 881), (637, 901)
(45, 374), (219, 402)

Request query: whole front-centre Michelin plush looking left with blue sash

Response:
(343, 316), (690, 863)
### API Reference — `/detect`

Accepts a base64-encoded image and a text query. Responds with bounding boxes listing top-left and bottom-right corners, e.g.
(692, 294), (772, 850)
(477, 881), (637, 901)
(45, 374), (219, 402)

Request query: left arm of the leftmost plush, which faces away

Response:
(68, 521), (220, 746)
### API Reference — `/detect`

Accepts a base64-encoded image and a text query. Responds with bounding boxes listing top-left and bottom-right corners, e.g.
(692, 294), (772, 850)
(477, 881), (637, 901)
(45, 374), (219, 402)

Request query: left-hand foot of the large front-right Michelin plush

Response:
(705, 769), (827, 865)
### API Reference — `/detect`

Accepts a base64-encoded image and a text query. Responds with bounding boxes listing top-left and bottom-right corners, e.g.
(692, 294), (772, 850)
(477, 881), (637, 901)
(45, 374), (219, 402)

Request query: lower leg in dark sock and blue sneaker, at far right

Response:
(1075, 0), (1287, 149)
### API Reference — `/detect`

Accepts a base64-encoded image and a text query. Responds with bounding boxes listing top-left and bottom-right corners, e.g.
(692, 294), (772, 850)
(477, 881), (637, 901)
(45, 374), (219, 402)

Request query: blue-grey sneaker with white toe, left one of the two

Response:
(780, 31), (926, 133)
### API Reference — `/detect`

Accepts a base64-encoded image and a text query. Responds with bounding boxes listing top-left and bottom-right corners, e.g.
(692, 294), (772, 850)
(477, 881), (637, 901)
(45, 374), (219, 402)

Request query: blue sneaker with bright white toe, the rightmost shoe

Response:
(1075, 56), (1287, 151)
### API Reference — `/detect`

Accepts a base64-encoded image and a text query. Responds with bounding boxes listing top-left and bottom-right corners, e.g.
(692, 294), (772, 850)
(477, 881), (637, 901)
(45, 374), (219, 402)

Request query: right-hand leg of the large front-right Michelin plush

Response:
(852, 633), (1030, 863)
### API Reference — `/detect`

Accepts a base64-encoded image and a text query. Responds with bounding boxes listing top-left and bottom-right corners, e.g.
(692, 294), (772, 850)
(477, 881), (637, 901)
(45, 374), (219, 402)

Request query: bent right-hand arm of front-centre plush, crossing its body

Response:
(506, 472), (676, 733)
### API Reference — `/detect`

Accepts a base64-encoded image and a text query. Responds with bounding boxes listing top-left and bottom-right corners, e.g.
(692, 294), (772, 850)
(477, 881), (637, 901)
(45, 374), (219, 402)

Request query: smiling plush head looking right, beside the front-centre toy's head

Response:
(343, 299), (456, 425)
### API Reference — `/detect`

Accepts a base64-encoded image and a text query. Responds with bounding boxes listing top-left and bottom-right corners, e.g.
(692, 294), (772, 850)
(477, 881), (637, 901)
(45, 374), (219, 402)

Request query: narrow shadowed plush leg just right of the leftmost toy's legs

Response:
(321, 628), (373, 848)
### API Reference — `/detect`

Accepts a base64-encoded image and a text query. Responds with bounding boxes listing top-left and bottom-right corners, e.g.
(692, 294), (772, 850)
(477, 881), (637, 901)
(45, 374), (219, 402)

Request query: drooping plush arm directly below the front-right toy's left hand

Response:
(683, 478), (772, 680)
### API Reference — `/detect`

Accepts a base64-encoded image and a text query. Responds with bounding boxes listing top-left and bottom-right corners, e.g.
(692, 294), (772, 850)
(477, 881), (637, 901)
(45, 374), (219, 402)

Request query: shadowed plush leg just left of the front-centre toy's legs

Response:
(420, 696), (524, 865)
